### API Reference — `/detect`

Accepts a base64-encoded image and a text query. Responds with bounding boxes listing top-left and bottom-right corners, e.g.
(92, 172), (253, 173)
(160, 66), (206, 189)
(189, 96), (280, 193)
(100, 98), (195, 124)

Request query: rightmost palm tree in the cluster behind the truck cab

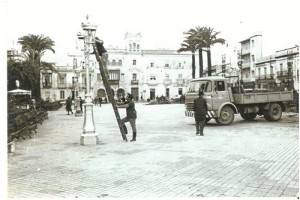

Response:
(201, 27), (225, 76)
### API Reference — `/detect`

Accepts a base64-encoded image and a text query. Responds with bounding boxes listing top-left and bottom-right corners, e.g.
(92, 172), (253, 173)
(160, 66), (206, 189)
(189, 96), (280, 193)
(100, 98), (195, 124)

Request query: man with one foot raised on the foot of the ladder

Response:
(117, 93), (137, 142)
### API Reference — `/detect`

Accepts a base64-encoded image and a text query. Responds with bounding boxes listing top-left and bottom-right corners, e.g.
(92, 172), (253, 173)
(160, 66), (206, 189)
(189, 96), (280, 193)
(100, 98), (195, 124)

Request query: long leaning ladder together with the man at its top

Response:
(93, 37), (127, 142)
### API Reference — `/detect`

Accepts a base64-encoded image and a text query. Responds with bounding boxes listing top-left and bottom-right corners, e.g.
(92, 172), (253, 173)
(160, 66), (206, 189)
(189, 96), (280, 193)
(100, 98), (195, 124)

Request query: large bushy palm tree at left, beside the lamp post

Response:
(18, 34), (57, 99)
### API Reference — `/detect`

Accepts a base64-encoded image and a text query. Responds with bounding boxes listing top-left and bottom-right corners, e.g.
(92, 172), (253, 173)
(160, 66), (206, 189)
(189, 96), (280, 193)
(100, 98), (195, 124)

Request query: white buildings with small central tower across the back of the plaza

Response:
(41, 33), (192, 101)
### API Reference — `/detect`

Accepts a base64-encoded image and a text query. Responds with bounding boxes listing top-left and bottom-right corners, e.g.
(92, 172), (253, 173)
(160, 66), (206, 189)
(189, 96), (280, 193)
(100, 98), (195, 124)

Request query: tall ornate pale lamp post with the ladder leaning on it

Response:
(77, 16), (99, 145)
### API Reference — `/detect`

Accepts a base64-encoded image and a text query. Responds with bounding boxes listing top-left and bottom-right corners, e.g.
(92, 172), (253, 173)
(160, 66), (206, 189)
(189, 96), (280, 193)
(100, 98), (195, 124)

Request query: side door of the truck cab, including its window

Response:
(211, 80), (230, 110)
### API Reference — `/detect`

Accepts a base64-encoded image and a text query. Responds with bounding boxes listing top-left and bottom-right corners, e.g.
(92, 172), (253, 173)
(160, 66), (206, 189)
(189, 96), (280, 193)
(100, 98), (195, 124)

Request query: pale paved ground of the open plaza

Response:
(7, 103), (299, 198)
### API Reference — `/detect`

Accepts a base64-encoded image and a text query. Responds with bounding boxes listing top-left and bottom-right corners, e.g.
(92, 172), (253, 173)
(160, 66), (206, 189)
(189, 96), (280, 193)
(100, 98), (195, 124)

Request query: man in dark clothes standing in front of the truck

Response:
(194, 91), (207, 136)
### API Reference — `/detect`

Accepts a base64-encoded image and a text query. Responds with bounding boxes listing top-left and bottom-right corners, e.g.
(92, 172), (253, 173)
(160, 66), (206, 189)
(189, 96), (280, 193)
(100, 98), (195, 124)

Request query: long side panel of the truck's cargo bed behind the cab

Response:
(233, 91), (293, 104)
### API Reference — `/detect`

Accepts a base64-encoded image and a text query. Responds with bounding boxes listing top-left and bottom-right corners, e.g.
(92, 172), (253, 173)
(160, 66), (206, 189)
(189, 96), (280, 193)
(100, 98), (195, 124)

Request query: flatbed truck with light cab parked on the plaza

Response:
(185, 76), (293, 125)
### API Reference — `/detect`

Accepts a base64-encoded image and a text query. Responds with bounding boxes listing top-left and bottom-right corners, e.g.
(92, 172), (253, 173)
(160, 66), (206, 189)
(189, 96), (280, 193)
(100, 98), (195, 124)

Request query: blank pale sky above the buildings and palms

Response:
(1, 0), (300, 65)
